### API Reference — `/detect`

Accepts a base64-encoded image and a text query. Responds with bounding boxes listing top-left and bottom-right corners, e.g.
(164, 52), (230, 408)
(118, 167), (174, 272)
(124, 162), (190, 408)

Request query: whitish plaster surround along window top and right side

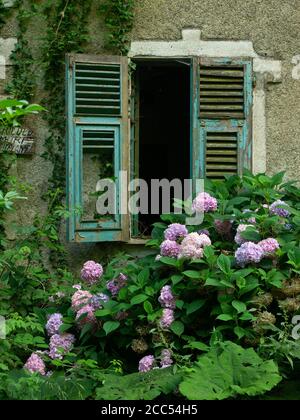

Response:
(128, 29), (282, 173)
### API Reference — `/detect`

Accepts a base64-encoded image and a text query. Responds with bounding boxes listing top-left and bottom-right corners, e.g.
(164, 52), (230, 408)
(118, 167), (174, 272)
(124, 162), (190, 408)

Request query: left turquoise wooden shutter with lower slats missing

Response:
(66, 54), (129, 242)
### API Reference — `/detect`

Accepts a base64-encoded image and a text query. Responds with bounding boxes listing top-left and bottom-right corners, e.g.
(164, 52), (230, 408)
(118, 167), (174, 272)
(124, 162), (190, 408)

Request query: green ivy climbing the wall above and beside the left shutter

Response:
(0, 0), (135, 267)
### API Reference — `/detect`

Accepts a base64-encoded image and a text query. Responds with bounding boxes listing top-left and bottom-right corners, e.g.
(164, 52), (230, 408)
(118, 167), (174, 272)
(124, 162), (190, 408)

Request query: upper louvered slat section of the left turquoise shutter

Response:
(75, 63), (121, 116)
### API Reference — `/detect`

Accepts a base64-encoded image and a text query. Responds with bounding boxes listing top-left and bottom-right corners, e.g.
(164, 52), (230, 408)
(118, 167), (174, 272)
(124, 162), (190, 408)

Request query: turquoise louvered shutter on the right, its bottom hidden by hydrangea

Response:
(193, 58), (253, 179)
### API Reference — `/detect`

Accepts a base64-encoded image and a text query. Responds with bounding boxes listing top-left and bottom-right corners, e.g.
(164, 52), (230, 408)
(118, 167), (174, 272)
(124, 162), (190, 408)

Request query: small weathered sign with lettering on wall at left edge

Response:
(0, 127), (34, 155)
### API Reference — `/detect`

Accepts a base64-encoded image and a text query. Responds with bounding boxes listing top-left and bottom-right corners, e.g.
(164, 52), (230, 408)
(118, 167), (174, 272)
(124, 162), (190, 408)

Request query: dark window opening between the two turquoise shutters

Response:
(136, 60), (190, 236)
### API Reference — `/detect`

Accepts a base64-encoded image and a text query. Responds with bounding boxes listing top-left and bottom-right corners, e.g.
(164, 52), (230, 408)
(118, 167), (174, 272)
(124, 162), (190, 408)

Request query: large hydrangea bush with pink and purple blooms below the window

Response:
(0, 173), (300, 399)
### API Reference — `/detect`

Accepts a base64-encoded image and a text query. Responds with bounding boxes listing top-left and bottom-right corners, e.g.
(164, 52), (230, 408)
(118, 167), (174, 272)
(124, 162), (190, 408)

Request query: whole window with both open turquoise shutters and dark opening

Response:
(67, 54), (252, 242)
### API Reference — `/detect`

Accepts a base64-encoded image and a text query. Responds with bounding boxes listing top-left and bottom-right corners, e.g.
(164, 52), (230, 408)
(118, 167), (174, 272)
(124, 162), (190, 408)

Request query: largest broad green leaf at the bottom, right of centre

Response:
(179, 341), (282, 401)
